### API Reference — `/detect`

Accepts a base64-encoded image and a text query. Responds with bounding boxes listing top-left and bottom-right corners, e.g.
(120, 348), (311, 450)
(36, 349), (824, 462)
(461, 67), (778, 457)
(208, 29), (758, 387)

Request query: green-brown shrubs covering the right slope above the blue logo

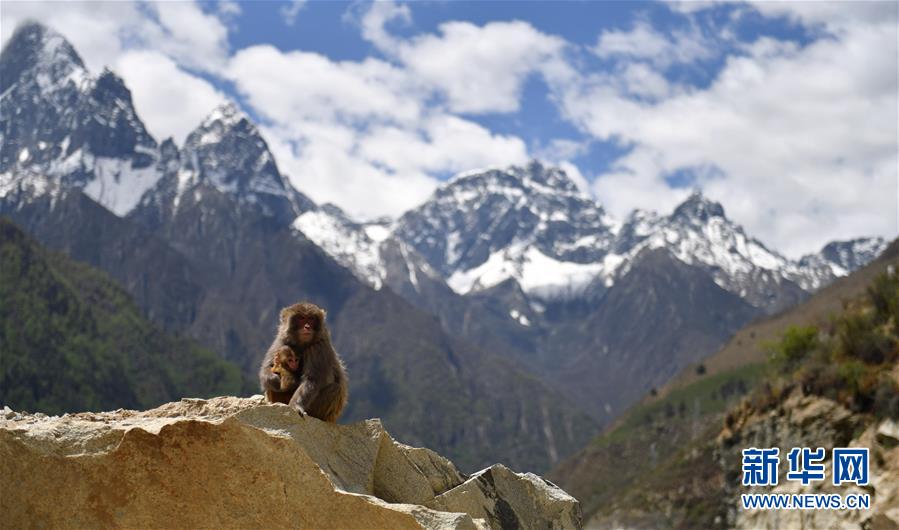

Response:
(755, 274), (899, 418)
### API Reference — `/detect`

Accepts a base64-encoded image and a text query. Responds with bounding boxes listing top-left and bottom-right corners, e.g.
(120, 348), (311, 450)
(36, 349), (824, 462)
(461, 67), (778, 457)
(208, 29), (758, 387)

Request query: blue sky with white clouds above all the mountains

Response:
(2, 0), (899, 257)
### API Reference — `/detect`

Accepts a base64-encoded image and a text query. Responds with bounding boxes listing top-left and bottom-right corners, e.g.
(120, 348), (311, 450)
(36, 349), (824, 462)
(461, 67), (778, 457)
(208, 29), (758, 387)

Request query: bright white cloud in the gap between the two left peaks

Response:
(115, 51), (226, 145)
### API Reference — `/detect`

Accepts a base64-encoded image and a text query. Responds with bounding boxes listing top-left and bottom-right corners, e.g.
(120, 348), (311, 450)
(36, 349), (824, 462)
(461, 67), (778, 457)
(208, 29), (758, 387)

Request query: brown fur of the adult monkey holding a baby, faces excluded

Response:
(259, 303), (348, 422)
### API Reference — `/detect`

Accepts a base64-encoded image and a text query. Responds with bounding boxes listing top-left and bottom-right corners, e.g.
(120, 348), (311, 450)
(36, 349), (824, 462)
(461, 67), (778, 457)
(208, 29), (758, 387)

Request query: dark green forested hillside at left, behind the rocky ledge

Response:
(0, 219), (247, 414)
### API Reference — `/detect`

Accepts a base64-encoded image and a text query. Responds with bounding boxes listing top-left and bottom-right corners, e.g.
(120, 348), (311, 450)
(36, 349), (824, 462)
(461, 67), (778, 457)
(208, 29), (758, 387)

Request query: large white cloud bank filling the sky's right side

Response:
(554, 3), (897, 257)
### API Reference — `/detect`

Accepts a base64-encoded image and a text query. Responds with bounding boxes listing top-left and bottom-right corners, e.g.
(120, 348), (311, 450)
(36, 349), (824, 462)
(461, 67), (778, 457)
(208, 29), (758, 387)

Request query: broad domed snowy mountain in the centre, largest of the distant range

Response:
(394, 161), (615, 296)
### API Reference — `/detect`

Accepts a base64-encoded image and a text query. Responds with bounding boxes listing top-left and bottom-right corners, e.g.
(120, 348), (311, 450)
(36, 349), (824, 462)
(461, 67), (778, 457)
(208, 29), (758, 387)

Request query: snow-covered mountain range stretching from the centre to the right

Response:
(295, 161), (886, 311)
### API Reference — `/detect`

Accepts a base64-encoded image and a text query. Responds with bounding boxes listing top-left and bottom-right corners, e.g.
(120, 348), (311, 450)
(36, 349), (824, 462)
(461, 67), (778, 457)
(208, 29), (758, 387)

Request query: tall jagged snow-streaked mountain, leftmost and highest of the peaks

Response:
(0, 20), (159, 215)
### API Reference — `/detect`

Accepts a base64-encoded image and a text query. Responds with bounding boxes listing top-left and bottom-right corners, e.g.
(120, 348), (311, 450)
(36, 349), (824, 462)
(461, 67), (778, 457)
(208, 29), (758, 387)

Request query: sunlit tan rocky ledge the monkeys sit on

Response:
(0, 396), (582, 529)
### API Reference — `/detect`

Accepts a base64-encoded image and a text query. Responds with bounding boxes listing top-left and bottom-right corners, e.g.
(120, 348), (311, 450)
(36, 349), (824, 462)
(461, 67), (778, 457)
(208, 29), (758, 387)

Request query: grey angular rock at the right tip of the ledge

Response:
(430, 464), (583, 530)
